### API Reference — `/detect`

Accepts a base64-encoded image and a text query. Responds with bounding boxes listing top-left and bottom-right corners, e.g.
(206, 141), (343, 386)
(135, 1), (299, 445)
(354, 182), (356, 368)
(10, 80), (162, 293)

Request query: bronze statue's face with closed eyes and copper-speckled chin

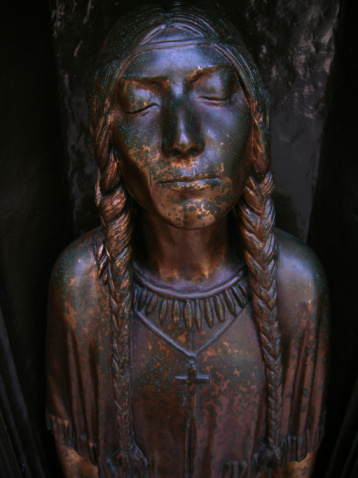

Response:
(111, 40), (251, 229)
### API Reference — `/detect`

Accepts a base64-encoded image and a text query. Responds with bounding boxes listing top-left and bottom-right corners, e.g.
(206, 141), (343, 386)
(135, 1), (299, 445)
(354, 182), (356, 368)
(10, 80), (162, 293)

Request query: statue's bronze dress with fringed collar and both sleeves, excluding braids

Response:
(47, 230), (327, 478)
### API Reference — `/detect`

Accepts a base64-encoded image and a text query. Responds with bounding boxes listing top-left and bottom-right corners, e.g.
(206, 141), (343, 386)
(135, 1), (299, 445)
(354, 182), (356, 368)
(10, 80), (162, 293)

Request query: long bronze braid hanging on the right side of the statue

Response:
(238, 121), (282, 466)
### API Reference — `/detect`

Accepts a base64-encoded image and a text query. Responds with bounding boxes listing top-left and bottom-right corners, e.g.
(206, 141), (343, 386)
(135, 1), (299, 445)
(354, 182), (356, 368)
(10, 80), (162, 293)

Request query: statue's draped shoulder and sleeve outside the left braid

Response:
(46, 231), (108, 434)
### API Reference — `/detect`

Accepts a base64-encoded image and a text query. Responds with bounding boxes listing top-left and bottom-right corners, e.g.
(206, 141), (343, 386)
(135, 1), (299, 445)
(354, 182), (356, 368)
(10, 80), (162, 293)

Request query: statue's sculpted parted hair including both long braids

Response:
(89, 4), (282, 477)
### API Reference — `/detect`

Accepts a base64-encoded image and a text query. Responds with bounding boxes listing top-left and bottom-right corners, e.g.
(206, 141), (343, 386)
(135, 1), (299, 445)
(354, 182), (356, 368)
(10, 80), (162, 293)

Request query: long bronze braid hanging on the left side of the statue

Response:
(95, 99), (147, 477)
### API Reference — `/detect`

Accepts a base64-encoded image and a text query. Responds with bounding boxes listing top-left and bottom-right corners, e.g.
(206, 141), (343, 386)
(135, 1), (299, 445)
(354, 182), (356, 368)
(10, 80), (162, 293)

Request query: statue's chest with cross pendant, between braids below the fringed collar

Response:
(131, 307), (265, 477)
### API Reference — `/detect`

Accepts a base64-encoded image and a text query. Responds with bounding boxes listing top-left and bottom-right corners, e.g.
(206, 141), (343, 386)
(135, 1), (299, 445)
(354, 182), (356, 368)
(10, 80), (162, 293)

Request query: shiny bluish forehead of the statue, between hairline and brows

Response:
(122, 44), (232, 78)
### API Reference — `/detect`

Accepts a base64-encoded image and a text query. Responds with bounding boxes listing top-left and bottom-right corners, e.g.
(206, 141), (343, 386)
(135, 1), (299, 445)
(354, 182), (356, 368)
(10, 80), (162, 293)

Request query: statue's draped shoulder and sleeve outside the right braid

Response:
(277, 231), (329, 461)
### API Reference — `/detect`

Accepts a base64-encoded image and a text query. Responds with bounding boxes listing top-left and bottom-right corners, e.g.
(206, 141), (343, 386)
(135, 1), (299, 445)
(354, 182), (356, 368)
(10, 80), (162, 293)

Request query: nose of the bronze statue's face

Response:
(162, 98), (204, 159)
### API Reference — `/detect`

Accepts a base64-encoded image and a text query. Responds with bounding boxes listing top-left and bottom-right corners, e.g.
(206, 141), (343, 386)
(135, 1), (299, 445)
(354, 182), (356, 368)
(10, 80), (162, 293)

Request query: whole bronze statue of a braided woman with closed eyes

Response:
(48, 4), (327, 478)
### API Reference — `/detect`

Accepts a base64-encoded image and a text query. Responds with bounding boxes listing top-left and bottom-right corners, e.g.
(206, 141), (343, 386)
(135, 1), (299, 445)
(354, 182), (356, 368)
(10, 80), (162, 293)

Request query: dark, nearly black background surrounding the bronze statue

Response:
(0, 0), (358, 478)
